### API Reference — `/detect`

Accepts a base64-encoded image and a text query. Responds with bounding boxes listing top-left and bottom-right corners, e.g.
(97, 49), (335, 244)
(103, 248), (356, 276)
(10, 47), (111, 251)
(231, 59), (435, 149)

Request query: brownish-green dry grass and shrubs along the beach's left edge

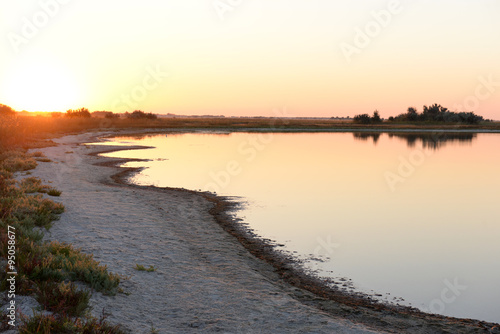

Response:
(0, 146), (120, 333)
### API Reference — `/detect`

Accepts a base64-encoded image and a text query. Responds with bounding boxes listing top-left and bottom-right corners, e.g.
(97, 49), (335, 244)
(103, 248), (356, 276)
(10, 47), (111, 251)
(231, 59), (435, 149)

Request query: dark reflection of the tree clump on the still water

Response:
(353, 131), (477, 150)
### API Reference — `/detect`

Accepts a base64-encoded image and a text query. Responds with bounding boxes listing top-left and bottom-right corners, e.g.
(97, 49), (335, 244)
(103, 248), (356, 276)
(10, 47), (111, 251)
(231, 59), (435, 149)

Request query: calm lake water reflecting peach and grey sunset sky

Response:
(95, 133), (500, 322)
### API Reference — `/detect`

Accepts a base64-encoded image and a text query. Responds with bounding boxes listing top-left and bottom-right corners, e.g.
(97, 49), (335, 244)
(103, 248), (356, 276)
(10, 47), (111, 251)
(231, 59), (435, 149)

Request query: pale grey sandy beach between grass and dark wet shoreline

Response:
(10, 133), (500, 333)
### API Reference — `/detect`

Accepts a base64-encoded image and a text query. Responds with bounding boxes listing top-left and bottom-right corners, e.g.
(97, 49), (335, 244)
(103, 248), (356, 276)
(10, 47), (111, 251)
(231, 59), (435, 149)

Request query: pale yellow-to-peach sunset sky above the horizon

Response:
(0, 0), (500, 119)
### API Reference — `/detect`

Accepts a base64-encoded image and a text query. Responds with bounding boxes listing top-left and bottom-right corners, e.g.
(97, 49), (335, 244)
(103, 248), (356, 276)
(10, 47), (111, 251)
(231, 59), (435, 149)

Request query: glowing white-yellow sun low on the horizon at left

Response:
(2, 61), (81, 111)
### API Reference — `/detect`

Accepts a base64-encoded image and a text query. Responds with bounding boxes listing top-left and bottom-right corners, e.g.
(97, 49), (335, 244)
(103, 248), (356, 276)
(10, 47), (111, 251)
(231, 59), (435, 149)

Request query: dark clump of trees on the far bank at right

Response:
(354, 104), (485, 124)
